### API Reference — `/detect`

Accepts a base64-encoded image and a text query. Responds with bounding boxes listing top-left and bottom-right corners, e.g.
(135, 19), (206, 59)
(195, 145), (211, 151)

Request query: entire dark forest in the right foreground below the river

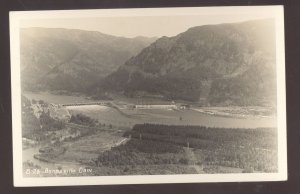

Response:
(95, 124), (277, 173)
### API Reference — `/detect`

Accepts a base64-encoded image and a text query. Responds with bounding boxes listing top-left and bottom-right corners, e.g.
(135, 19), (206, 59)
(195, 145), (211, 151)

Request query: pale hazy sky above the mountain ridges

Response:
(21, 14), (274, 37)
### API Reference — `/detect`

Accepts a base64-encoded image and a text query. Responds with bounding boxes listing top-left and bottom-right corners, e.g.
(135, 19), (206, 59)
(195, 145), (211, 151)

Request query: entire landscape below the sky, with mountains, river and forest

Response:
(20, 19), (280, 177)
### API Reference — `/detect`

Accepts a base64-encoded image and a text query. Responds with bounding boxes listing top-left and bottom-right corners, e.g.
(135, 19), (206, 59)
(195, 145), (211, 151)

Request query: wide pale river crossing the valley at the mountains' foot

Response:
(23, 92), (277, 128)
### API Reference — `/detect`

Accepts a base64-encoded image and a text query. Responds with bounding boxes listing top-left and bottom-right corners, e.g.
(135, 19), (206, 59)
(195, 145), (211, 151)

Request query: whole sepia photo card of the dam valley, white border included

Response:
(10, 6), (287, 186)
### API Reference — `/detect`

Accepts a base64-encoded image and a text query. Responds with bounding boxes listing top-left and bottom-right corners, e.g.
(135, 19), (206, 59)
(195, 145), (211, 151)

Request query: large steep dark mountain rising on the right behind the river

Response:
(98, 19), (276, 106)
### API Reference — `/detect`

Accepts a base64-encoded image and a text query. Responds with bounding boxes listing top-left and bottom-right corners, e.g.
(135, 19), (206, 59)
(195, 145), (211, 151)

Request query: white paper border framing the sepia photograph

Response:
(9, 6), (287, 187)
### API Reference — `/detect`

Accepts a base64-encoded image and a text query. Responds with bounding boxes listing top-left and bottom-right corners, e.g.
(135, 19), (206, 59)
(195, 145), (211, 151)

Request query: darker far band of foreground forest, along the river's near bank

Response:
(125, 124), (277, 149)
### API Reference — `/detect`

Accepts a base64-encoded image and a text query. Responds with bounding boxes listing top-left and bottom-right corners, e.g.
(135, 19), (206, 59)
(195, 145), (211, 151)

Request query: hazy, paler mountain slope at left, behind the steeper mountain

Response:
(20, 28), (155, 92)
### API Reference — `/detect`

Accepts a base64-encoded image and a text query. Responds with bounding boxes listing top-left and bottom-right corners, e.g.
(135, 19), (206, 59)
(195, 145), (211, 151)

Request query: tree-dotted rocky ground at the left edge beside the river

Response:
(22, 96), (100, 142)
